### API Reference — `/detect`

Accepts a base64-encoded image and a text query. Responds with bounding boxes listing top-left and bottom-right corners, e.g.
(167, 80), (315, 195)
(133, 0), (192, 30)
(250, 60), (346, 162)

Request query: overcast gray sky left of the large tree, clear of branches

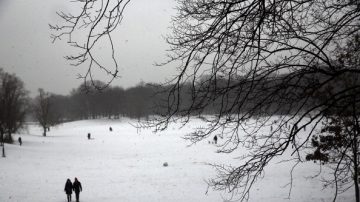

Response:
(0, 0), (175, 95)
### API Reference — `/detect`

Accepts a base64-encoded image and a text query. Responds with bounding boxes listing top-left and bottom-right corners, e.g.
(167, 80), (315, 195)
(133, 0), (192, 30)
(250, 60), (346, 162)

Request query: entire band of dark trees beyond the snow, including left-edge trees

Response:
(0, 69), (360, 142)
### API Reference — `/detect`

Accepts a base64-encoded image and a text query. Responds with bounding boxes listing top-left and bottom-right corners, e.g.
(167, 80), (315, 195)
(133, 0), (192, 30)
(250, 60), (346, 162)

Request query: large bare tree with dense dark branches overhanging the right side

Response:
(53, 0), (360, 200)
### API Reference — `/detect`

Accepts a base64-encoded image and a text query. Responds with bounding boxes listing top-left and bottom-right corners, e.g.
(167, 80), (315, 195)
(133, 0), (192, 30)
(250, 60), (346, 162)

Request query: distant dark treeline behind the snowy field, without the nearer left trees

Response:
(39, 71), (358, 121)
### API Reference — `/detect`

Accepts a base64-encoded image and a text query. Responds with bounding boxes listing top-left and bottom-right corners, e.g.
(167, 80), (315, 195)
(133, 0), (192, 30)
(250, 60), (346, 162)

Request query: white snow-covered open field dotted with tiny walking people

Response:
(0, 119), (354, 202)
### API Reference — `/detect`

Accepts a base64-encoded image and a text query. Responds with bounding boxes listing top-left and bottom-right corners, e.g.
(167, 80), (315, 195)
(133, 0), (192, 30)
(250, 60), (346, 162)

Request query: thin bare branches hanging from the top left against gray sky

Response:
(49, 0), (130, 90)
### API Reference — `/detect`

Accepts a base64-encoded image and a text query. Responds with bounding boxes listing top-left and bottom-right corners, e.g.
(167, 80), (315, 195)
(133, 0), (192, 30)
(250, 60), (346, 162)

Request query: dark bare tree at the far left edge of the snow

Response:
(0, 69), (28, 157)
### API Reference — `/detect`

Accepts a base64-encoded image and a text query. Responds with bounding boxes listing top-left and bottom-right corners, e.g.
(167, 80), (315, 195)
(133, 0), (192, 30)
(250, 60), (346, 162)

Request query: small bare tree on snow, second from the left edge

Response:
(33, 88), (61, 136)
